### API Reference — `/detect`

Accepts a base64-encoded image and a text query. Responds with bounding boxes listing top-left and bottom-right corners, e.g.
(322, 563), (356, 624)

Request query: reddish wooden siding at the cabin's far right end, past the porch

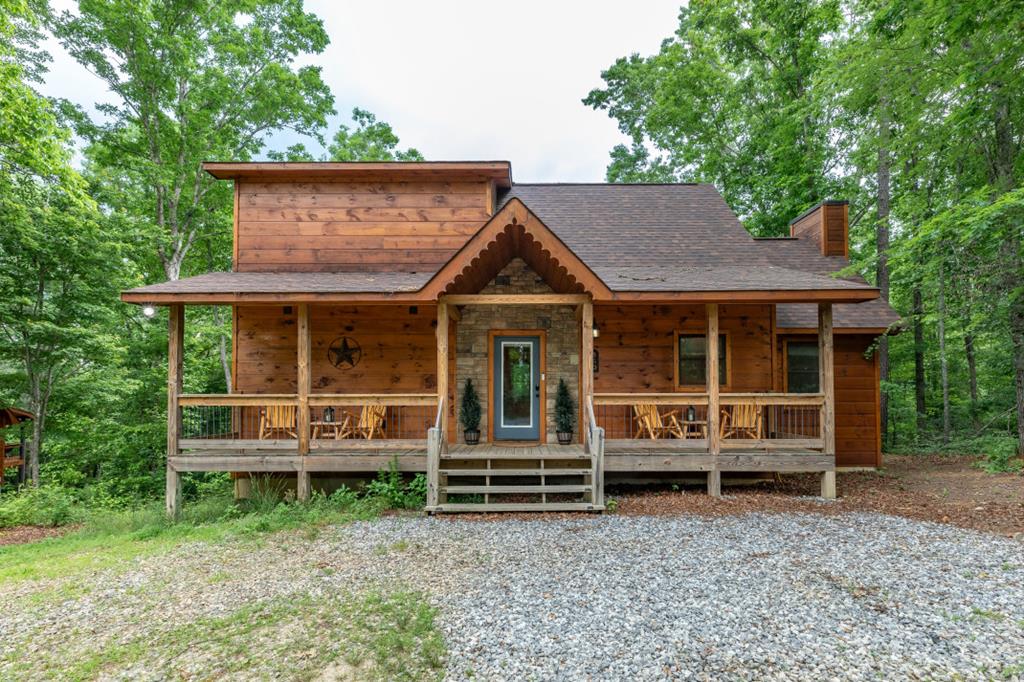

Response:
(776, 334), (882, 467)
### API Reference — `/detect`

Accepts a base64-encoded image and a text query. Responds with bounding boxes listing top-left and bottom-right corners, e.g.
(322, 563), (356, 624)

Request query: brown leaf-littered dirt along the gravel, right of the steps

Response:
(606, 455), (1024, 537)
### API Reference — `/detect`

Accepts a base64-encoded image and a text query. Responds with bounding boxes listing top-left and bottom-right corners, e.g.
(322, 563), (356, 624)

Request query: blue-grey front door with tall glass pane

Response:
(492, 336), (541, 440)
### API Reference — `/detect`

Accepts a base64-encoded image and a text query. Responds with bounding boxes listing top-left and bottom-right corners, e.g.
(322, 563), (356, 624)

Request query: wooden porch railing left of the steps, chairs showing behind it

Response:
(178, 393), (437, 451)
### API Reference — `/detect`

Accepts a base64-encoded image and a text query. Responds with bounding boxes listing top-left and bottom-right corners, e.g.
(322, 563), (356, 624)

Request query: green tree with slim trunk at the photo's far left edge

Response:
(0, 0), (121, 483)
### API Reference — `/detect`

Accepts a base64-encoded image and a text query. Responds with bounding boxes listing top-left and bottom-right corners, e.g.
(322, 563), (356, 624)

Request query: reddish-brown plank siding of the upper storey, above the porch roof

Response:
(236, 180), (492, 272)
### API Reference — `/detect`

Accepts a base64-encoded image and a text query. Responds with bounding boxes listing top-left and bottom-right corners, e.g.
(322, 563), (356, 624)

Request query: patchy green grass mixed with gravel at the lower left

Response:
(0, 481), (445, 680)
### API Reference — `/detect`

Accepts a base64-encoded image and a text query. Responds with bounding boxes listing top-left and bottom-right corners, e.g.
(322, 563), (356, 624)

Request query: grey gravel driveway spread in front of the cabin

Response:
(0, 514), (1024, 680)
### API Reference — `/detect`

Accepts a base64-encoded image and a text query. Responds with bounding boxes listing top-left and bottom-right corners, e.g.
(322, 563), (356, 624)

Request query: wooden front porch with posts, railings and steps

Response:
(167, 286), (836, 513)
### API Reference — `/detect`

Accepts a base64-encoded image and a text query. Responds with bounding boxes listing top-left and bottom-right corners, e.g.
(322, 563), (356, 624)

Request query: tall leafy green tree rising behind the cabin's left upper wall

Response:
(53, 0), (334, 280)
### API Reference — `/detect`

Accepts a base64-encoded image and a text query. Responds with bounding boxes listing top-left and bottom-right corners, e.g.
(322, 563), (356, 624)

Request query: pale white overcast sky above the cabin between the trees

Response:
(37, 0), (680, 182)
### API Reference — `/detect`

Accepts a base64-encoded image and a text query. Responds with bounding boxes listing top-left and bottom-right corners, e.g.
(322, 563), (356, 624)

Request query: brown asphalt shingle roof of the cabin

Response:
(123, 183), (897, 328)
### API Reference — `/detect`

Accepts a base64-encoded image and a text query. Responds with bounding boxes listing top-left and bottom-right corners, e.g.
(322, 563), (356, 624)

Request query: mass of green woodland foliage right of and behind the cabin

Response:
(585, 0), (1024, 467)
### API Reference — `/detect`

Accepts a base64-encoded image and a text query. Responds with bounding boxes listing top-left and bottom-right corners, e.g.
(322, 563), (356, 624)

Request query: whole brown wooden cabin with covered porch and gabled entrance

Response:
(122, 162), (897, 514)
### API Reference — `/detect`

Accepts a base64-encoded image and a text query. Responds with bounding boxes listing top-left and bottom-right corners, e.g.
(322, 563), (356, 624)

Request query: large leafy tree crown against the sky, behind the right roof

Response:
(584, 0), (842, 235)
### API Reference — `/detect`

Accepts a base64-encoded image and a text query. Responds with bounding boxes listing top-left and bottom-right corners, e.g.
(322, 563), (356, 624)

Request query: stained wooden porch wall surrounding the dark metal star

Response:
(236, 305), (437, 393)
